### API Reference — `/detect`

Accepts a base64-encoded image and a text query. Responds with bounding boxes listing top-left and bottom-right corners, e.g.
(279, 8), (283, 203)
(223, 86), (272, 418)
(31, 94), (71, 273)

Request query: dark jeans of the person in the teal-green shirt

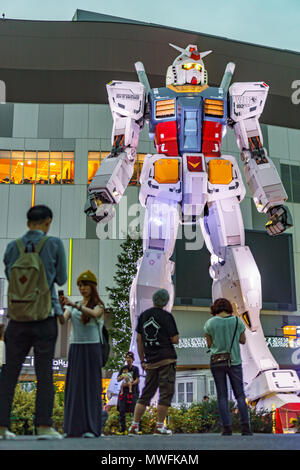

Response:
(211, 365), (249, 426)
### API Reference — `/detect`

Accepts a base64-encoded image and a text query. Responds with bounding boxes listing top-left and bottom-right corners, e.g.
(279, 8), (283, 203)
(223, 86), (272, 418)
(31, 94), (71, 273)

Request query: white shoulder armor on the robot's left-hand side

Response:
(106, 80), (145, 121)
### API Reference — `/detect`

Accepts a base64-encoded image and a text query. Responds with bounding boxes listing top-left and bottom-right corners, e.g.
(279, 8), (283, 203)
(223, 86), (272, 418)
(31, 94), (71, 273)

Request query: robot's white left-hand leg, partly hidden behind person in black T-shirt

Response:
(130, 197), (179, 363)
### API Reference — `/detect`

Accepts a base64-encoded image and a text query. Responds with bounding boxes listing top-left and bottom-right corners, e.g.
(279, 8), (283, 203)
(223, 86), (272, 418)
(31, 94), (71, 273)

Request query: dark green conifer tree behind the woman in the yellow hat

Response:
(105, 235), (143, 372)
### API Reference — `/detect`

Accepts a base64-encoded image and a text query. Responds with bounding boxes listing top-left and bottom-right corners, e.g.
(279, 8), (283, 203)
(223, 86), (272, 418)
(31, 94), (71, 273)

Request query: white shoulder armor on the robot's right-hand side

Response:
(229, 82), (269, 122)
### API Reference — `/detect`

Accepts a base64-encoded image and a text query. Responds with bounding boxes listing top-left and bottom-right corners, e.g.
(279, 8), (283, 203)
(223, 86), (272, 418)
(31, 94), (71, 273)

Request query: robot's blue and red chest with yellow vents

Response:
(150, 96), (227, 157)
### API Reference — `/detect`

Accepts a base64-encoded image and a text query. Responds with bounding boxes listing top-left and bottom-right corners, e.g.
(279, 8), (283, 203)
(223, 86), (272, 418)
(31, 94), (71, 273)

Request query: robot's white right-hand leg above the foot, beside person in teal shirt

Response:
(201, 198), (279, 384)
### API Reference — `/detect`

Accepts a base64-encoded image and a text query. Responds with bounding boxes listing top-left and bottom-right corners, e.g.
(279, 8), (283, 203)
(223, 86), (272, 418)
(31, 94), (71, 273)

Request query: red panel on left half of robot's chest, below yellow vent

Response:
(155, 121), (178, 157)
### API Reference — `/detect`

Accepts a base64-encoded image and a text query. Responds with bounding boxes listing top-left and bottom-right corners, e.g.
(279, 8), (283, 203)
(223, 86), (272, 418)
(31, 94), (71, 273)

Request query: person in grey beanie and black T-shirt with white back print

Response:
(128, 289), (179, 436)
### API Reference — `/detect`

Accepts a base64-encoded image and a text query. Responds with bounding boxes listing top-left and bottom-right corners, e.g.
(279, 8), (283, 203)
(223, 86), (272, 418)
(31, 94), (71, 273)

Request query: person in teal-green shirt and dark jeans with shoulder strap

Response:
(204, 298), (252, 436)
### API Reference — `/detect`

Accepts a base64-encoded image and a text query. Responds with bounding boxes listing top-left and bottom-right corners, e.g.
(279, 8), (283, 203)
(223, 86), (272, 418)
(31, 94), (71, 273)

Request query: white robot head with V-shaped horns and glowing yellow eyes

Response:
(166, 44), (212, 86)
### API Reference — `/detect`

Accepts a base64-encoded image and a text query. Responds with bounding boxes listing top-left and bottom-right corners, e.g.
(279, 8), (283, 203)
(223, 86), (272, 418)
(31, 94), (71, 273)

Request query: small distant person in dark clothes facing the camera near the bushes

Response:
(117, 351), (140, 434)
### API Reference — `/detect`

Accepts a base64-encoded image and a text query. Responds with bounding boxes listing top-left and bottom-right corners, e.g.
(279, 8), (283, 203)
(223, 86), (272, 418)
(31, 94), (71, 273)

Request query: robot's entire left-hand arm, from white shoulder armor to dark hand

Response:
(84, 81), (145, 223)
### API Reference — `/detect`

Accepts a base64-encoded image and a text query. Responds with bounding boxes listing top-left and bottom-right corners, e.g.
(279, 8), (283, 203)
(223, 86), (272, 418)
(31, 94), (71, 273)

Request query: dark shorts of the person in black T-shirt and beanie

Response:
(137, 362), (176, 406)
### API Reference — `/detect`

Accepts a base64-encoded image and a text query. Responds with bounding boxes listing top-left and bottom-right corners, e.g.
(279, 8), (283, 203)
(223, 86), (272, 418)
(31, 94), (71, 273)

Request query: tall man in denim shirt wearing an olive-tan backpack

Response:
(0, 205), (67, 439)
